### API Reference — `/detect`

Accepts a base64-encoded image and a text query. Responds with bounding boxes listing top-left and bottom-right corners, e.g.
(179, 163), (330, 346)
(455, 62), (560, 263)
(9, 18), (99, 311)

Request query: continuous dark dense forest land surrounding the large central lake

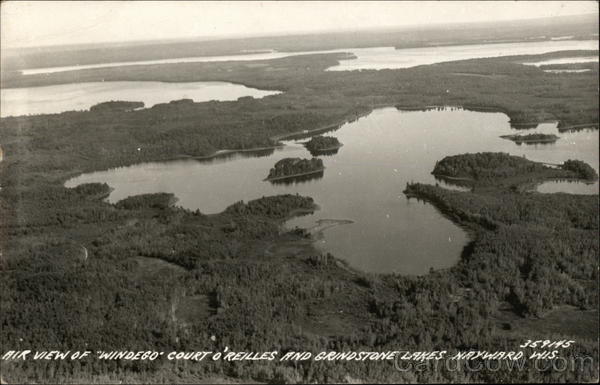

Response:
(0, 39), (599, 383)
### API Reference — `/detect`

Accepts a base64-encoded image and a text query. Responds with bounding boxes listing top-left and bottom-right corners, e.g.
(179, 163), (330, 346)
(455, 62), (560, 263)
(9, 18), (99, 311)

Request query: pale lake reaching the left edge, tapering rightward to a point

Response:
(0, 81), (279, 117)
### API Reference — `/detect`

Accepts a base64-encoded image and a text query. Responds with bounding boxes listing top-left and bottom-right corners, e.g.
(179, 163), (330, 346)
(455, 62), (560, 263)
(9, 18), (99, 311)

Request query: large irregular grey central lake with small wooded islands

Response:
(66, 108), (598, 274)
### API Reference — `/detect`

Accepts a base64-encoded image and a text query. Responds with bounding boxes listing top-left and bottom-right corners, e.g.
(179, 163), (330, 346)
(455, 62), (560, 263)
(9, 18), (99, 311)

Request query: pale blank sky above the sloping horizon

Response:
(0, 0), (598, 48)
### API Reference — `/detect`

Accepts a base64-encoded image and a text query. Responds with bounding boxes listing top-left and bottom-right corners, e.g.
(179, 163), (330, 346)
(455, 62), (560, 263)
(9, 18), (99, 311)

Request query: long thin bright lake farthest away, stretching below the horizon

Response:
(16, 40), (598, 75)
